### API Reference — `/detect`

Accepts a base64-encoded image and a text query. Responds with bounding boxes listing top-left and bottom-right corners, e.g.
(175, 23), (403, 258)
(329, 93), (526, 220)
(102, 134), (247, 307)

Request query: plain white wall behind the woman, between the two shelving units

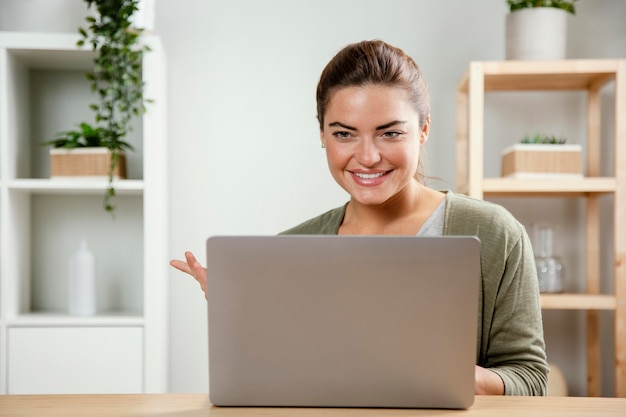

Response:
(156, 0), (505, 391)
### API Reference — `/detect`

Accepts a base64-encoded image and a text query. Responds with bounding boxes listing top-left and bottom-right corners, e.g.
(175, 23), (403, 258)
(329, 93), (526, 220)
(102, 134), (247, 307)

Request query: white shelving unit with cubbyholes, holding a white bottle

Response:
(0, 32), (168, 394)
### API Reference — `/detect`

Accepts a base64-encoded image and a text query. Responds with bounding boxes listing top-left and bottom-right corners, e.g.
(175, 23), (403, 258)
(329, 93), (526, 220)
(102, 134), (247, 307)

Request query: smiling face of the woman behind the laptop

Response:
(320, 85), (429, 205)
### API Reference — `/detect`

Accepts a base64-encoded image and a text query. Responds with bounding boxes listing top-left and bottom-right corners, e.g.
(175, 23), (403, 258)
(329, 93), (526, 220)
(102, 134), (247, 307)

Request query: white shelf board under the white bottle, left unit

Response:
(7, 311), (145, 327)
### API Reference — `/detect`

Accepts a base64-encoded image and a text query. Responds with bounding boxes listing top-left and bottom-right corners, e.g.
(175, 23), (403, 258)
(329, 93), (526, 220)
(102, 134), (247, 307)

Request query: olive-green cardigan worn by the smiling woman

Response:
(282, 191), (548, 395)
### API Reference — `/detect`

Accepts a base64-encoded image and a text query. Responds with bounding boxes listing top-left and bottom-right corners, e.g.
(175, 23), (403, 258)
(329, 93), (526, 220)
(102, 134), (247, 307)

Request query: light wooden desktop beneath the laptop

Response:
(0, 394), (626, 417)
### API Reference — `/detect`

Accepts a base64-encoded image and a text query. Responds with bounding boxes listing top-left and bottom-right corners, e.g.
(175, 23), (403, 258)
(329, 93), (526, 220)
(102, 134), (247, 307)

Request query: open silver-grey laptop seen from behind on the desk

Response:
(206, 235), (480, 409)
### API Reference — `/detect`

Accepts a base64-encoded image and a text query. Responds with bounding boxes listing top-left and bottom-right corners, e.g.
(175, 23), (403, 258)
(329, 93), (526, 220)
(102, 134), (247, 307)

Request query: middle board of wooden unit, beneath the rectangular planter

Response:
(483, 177), (617, 197)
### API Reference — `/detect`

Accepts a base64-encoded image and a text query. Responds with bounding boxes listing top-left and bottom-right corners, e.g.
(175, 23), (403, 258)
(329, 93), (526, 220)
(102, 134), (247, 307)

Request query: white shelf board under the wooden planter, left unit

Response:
(7, 178), (144, 195)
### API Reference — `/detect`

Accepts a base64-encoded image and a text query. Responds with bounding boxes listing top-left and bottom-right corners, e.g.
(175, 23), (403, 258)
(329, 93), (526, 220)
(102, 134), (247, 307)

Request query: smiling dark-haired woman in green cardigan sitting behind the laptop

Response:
(171, 41), (548, 395)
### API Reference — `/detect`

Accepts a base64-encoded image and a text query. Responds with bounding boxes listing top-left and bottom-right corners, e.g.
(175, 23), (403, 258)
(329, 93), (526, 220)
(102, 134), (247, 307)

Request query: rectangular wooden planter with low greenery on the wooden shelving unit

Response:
(501, 133), (583, 178)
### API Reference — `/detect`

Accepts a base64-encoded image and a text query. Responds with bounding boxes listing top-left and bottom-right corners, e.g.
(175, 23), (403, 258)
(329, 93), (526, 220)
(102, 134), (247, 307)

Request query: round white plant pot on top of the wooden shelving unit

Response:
(506, 7), (568, 60)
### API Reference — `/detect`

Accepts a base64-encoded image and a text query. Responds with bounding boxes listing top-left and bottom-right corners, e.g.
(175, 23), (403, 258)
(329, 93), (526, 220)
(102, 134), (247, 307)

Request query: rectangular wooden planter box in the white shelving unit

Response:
(50, 148), (126, 179)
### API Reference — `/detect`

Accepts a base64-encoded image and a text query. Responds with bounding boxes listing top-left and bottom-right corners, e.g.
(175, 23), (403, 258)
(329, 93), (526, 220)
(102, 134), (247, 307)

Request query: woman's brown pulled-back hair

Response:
(317, 40), (430, 130)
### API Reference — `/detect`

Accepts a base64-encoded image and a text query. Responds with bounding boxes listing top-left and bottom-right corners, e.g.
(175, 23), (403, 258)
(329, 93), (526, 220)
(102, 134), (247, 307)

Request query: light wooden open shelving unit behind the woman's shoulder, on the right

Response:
(456, 60), (626, 397)
